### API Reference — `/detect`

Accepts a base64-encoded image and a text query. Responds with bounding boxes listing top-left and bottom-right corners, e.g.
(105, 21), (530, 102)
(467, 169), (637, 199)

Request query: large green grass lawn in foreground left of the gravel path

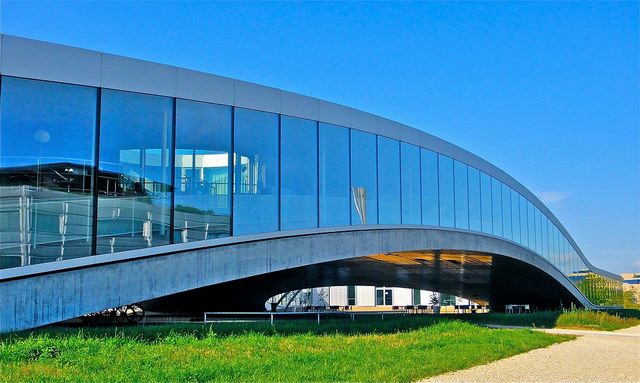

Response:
(0, 317), (572, 382)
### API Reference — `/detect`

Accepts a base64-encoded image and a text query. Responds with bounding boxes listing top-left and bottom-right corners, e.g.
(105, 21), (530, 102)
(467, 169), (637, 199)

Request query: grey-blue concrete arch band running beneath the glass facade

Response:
(0, 225), (593, 332)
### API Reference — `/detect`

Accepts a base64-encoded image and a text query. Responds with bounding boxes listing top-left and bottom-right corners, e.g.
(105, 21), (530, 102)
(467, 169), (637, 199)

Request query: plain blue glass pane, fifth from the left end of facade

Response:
(280, 116), (318, 230)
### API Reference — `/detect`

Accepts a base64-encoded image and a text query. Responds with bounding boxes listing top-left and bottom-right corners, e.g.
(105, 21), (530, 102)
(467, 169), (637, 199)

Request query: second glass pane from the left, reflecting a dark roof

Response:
(97, 89), (173, 253)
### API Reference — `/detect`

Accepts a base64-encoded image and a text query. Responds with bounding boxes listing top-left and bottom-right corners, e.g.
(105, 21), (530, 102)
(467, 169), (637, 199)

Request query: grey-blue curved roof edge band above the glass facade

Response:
(0, 34), (621, 280)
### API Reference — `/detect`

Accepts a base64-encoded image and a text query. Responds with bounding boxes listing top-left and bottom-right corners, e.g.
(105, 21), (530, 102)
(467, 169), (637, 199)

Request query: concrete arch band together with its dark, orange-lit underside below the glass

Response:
(0, 227), (592, 331)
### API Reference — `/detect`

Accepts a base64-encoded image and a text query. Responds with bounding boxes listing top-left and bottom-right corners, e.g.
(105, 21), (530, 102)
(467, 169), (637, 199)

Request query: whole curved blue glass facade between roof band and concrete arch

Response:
(0, 77), (621, 305)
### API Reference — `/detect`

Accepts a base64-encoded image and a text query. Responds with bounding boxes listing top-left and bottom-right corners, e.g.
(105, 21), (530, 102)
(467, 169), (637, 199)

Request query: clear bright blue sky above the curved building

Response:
(0, 1), (640, 273)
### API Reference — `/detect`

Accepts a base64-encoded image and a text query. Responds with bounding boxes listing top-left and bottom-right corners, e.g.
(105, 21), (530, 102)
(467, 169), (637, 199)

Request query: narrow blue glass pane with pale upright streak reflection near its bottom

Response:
(351, 130), (378, 225)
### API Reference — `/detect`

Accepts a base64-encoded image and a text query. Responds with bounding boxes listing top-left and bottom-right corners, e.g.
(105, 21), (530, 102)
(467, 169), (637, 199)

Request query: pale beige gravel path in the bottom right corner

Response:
(420, 326), (640, 383)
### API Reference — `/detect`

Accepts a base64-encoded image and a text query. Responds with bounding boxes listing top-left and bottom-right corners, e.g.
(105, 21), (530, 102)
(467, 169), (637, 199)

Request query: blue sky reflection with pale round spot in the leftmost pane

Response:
(0, 77), (97, 167)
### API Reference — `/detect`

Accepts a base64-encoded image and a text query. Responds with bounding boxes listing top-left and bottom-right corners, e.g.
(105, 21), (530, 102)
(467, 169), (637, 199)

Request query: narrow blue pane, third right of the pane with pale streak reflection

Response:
(420, 149), (440, 226)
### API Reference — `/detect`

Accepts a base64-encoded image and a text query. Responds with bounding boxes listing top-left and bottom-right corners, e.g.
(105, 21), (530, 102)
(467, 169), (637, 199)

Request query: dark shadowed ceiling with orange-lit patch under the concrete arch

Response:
(143, 250), (580, 313)
